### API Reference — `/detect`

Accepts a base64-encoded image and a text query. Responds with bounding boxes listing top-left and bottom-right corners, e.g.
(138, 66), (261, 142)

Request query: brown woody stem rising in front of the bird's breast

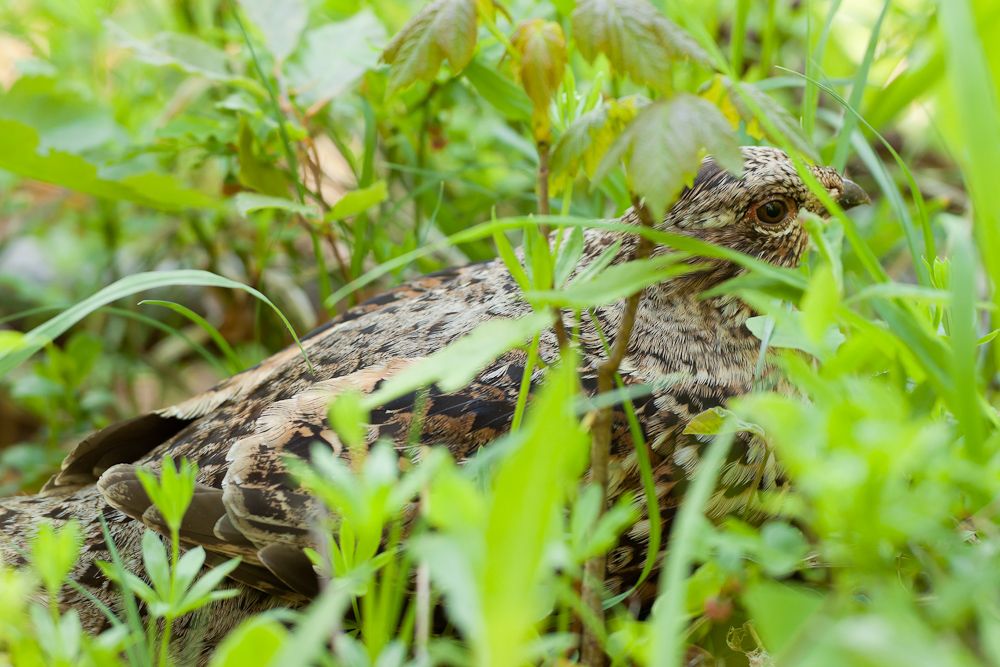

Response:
(580, 193), (656, 667)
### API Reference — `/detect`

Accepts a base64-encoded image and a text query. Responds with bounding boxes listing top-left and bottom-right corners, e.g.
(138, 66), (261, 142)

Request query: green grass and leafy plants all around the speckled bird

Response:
(0, 0), (1000, 667)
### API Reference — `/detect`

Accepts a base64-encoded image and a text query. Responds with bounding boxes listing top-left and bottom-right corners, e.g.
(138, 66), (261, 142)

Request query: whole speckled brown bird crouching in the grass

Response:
(0, 147), (868, 658)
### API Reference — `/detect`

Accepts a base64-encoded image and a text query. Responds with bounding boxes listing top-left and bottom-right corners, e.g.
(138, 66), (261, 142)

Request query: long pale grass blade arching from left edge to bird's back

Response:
(0, 268), (311, 377)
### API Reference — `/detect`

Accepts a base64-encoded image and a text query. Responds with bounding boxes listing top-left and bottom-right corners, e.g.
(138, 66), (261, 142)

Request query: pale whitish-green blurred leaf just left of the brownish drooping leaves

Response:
(288, 8), (386, 105)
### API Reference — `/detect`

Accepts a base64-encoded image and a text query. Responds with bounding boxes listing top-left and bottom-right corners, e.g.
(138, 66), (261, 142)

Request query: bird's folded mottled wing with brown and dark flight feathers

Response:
(65, 260), (528, 600)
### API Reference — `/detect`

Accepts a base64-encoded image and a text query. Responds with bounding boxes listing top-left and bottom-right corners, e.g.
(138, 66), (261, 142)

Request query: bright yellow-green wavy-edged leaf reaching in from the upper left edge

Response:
(0, 119), (218, 211)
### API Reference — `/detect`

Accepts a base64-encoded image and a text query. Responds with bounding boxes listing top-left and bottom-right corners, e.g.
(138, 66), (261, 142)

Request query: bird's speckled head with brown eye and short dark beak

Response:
(662, 146), (870, 267)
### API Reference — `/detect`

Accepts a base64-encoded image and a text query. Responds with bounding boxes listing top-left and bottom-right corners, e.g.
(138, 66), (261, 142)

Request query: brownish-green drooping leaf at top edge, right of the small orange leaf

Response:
(572, 0), (712, 90)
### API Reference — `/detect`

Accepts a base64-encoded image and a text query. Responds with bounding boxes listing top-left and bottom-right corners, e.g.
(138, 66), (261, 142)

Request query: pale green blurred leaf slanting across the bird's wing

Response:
(363, 312), (553, 409)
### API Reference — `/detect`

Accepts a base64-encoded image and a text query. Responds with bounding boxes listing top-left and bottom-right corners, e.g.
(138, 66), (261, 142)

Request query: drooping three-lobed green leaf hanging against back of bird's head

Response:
(594, 93), (743, 217)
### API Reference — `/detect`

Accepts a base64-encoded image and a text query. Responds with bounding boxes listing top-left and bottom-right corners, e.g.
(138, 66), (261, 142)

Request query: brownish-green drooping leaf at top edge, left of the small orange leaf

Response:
(382, 0), (478, 95)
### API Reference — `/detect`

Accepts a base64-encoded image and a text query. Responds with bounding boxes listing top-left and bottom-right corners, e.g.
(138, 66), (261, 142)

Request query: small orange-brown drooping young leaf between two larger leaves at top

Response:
(511, 18), (566, 140)
